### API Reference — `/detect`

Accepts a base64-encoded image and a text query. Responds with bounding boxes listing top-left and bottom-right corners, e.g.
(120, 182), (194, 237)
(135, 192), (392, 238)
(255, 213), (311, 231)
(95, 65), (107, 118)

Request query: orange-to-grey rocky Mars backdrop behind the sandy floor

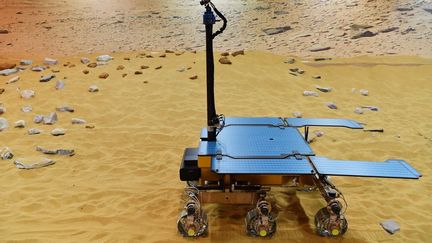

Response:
(0, 0), (432, 58)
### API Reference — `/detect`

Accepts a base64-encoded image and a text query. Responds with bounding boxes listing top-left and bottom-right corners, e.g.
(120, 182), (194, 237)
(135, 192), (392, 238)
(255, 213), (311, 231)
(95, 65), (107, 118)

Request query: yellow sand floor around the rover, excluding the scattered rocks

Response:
(0, 52), (432, 242)
